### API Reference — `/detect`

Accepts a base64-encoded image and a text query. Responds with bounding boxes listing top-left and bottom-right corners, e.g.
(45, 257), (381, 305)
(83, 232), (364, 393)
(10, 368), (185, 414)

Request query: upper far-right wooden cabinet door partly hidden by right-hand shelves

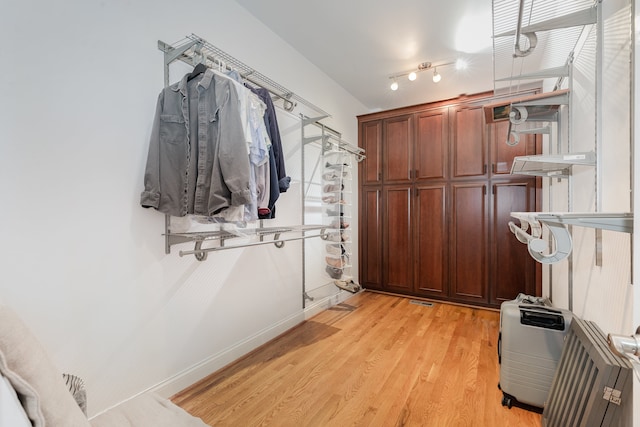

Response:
(487, 120), (536, 175)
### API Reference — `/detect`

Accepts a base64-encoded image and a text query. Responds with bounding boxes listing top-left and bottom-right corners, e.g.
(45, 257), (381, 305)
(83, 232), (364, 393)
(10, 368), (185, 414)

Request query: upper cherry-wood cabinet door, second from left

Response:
(382, 114), (413, 184)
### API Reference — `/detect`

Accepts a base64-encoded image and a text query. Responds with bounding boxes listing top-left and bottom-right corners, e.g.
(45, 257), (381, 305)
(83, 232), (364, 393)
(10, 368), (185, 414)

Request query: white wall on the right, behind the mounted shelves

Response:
(545, 0), (640, 426)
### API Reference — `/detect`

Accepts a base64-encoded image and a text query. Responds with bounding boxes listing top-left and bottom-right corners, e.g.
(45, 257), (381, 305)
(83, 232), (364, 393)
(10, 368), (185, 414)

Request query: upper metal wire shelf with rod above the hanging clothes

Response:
(158, 34), (330, 117)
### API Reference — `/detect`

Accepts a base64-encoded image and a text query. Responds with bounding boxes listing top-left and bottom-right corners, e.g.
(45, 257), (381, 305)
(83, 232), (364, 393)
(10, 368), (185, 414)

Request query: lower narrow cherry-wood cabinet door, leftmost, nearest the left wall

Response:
(359, 187), (382, 289)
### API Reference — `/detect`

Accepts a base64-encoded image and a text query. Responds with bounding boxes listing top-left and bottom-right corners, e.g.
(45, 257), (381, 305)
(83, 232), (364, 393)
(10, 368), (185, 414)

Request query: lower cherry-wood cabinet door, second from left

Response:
(382, 185), (413, 293)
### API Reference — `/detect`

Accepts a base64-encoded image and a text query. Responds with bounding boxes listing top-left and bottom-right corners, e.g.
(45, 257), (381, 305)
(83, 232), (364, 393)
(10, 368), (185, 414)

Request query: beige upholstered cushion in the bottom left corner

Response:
(0, 304), (90, 427)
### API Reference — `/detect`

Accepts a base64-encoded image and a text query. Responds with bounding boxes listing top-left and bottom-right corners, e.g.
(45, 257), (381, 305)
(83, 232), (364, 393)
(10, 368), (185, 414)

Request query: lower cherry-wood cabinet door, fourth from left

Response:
(449, 181), (489, 304)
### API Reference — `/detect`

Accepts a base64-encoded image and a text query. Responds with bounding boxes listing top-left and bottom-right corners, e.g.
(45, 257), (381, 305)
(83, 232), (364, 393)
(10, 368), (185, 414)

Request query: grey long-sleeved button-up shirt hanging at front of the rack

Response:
(140, 69), (251, 216)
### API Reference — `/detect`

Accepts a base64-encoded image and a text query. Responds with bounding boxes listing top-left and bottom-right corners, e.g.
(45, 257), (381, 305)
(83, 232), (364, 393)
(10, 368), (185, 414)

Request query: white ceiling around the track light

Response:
(236, 0), (500, 111)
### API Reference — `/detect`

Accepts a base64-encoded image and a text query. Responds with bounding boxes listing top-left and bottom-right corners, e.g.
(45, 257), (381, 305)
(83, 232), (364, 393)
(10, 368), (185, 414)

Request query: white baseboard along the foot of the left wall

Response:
(149, 292), (353, 398)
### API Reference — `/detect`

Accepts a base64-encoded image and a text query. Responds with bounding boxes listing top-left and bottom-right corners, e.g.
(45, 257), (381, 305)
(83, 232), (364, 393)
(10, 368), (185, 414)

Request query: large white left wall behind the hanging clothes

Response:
(0, 0), (366, 414)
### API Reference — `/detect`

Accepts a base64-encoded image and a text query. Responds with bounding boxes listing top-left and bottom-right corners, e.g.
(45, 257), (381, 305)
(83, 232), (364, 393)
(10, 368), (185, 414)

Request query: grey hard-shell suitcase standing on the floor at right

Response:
(498, 294), (573, 409)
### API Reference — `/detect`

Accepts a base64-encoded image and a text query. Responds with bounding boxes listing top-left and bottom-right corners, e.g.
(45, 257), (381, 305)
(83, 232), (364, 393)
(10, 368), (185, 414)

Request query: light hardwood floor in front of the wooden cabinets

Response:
(172, 292), (540, 427)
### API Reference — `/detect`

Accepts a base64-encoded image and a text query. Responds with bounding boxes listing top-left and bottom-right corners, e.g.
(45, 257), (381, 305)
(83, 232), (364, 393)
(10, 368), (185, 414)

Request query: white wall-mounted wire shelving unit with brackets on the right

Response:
(492, 0), (633, 270)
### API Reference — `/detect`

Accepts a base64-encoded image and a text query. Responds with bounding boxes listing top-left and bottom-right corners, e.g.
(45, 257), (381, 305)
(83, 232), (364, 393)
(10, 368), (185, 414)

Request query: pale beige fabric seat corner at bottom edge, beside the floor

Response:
(91, 393), (207, 427)
